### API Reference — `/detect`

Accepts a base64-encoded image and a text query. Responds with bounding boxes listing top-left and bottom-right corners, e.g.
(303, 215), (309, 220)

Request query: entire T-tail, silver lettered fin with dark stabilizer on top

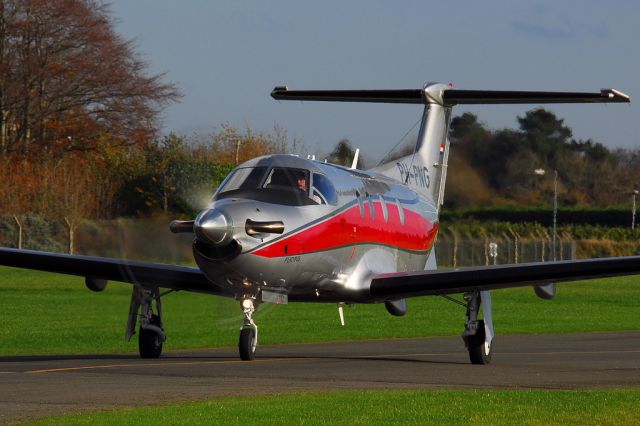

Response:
(271, 84), (630, 209)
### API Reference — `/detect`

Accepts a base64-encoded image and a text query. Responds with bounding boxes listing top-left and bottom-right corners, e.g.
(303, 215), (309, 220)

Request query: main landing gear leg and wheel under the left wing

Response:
(125, 286), (167, 358)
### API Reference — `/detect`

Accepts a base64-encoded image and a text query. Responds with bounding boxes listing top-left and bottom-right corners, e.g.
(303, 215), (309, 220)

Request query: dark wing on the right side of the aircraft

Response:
(370, 256), (640, 301)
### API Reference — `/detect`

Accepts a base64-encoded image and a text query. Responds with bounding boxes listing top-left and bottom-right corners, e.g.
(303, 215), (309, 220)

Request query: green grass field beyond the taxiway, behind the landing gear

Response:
(0, 267), (640, 355)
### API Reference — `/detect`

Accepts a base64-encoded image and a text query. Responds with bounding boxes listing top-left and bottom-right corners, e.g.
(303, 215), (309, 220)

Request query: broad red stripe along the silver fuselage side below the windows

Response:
(253, 201), (438, 257)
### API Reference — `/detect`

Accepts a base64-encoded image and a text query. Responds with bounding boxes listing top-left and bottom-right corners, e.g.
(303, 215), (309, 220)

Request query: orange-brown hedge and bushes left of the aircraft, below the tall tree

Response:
(0, 125), (299, 221)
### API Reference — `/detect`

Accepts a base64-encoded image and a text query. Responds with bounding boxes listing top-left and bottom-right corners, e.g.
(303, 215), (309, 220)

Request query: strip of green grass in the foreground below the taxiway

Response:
(27, 389), (640, 425)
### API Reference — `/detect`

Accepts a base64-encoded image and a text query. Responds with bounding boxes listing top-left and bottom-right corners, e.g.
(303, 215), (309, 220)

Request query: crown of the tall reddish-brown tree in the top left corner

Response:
(0, 0), (179, 155)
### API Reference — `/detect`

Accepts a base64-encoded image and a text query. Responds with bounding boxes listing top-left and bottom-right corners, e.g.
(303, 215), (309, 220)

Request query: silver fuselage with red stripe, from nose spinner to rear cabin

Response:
(194, 155), (438, 302)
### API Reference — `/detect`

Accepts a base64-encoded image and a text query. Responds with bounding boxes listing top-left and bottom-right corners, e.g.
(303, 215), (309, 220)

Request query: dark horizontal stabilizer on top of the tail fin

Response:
(271, 84), (630, 106)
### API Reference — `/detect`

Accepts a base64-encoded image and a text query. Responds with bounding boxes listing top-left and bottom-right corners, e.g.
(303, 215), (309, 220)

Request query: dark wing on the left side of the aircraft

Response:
(0, 248), (223, 294)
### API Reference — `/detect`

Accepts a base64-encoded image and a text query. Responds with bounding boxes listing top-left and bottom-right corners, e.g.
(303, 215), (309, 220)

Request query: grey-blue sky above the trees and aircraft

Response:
(111, 0), (640, 159)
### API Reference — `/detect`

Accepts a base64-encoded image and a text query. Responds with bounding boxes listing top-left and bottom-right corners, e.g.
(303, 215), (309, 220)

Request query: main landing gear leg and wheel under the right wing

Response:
(462, 291), (493, 364)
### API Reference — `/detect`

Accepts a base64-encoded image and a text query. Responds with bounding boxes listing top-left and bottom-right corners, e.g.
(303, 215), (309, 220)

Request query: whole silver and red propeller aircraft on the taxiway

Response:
(0, 84), (640, 364)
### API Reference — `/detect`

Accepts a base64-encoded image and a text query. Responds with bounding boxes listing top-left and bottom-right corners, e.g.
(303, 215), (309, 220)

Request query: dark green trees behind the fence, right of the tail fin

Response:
(445, 108), (640, 208)
